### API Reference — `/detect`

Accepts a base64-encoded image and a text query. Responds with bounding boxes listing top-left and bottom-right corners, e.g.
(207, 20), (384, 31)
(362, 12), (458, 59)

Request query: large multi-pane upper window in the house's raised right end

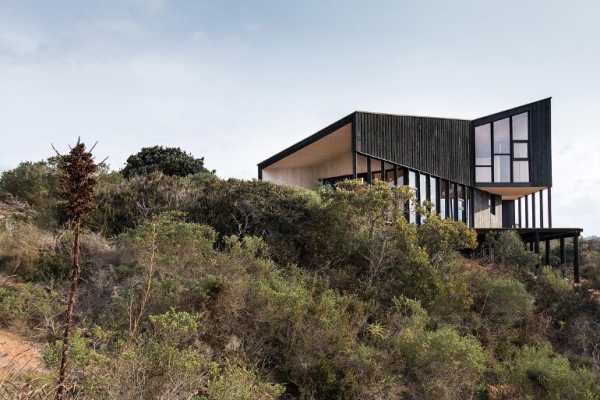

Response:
(475, 112), (529, 183)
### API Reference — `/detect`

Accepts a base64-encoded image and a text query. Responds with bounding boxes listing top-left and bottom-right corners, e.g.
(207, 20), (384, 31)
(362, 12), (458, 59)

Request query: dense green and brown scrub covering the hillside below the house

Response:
(0, 164), (600, 400)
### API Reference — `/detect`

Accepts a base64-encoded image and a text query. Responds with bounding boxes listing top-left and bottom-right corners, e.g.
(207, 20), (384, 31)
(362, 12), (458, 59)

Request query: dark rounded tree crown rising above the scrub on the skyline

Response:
(121, 146), (214, 178)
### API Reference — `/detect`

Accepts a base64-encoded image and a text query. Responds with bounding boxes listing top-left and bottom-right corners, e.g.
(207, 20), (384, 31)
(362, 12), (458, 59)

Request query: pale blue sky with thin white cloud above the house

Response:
(0, 0), (600, 236)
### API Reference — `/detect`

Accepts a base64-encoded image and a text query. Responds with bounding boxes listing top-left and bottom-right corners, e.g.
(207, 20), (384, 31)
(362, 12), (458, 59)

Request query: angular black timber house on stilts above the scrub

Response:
(258, 98), (582, 281)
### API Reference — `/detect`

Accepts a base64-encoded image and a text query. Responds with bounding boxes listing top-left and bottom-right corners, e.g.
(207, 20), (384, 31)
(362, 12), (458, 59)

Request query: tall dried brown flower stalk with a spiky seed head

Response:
(55, 140), (98, 400)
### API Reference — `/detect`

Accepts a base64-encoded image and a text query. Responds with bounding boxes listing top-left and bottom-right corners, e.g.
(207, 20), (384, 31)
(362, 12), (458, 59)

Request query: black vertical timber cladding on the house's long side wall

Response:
(355, 112), (472, 186)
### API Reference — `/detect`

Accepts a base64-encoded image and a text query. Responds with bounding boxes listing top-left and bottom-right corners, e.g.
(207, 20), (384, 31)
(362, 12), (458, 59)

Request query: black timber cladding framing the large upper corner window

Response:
(472, 98), (552, 187)
